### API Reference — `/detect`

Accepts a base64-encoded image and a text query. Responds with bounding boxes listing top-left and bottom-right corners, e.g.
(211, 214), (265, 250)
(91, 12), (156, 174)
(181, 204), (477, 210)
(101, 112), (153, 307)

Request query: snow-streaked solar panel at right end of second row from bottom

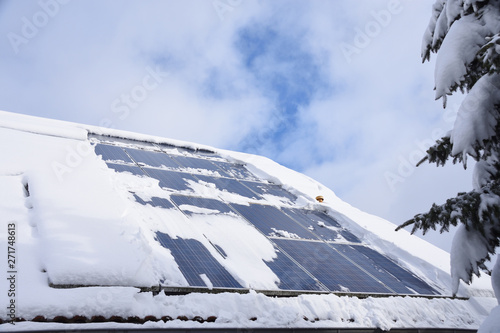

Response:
(283, 208), (360, 243)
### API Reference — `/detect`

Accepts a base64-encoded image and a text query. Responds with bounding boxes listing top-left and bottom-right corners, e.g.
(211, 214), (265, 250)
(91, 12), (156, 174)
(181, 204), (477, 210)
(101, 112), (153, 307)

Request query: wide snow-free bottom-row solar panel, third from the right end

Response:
(273, 239), (392, 293)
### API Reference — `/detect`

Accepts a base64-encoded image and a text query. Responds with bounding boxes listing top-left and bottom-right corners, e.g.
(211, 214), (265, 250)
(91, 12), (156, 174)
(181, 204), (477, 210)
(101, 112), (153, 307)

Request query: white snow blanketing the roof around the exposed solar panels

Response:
(0, 112), (494, 330)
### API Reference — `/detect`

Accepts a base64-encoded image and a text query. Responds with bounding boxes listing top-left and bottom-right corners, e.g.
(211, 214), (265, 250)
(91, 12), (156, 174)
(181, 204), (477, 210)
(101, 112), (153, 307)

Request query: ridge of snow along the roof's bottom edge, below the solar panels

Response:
(0, 287), (492, 331)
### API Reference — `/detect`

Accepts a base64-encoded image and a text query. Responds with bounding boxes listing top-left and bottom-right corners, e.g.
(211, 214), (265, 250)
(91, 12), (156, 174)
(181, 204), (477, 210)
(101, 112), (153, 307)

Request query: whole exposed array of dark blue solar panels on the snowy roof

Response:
(95, 140), (438, 295)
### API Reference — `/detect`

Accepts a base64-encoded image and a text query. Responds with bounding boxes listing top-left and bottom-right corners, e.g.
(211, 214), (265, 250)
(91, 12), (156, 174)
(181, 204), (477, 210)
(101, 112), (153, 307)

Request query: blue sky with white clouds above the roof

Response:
(0, 0), (472, 250)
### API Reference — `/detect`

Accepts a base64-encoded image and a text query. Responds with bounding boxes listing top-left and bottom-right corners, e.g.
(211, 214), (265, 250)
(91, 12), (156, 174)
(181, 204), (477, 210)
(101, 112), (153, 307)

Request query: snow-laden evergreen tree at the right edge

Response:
(397, 0), (500, 300)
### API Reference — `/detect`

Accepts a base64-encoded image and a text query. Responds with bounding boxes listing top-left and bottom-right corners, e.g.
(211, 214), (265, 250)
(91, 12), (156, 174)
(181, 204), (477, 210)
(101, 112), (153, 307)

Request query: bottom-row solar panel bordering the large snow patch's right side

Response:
(264, 246), (325, 290)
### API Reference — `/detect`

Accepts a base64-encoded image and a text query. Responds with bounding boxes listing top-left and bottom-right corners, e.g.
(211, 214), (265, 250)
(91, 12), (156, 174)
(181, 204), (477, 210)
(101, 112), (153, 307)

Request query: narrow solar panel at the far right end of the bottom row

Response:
(353, 246), (439, 295)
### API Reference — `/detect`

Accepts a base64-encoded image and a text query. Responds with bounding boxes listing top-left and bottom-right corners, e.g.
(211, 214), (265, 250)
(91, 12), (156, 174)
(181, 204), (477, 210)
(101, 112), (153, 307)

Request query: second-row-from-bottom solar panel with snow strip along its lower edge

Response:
(232, 204), (318, 240)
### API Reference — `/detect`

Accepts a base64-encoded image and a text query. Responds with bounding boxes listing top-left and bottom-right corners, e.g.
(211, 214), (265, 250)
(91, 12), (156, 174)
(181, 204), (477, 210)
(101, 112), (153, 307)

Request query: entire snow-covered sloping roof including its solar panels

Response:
(0, 112), (496, 330)
